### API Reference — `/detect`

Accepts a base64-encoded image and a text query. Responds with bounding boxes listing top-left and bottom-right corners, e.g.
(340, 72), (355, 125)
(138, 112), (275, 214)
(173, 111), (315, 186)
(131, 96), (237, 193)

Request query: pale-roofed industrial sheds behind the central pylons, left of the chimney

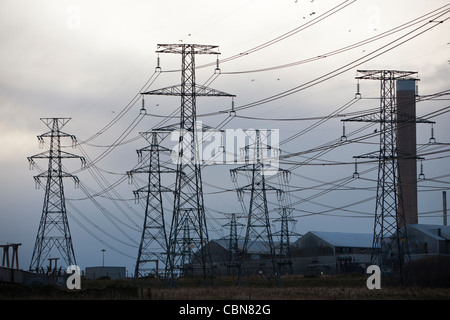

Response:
(200, 231), (372, 276)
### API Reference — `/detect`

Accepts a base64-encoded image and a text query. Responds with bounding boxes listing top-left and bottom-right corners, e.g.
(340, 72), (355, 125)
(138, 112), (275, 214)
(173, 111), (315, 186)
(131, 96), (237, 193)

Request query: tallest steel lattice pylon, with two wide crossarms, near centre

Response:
(142, 43), (234, 286)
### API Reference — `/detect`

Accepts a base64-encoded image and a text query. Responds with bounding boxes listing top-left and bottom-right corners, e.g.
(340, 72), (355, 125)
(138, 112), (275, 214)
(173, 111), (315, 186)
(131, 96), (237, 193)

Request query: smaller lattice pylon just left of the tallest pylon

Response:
(127, 131), (175, 279)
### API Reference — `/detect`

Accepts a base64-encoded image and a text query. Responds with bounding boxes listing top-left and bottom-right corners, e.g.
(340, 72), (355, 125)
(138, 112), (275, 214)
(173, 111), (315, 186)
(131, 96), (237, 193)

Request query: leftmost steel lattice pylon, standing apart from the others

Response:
(28, 118), (85, 271)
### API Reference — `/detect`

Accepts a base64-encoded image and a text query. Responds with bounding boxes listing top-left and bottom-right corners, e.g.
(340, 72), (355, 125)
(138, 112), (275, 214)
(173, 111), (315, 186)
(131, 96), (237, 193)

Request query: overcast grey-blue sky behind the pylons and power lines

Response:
(0, 0), (450, 272)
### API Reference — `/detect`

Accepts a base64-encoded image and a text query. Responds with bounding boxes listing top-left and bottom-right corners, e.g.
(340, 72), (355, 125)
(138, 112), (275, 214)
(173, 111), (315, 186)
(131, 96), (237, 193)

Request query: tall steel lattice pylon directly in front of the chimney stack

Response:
(342, 70), (429, 284)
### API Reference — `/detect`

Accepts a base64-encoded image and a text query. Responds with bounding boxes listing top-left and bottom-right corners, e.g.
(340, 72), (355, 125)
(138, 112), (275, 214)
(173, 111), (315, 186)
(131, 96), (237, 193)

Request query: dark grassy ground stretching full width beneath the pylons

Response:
(0, 275), (450, 300)
